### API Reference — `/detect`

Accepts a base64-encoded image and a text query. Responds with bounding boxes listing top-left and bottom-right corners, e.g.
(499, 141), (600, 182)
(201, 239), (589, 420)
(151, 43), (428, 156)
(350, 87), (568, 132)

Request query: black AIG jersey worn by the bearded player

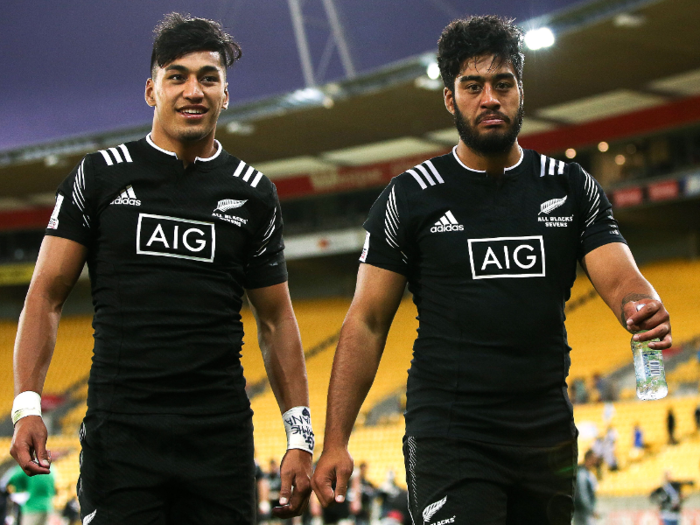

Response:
(360, 150), (625, 446)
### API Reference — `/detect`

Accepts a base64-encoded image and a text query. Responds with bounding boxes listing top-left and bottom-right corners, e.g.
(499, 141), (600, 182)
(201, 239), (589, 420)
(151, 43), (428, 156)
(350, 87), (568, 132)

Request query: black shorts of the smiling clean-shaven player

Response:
(77, 412), (255, 525)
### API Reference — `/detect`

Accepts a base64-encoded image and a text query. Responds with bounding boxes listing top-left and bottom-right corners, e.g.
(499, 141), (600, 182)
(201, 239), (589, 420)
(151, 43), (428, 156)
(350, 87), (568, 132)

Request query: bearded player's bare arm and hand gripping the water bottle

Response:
(581, 242), (672, 349)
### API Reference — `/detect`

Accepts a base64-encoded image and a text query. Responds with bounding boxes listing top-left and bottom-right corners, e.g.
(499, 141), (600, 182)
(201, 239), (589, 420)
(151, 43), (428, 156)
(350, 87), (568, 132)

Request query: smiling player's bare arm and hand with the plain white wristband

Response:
(10, 235), (87, 476)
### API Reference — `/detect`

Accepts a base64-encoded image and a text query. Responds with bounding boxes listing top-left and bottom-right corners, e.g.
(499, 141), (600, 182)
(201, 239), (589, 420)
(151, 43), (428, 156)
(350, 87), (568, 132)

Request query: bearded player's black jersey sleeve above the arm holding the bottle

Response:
(578, 166), (627, 259)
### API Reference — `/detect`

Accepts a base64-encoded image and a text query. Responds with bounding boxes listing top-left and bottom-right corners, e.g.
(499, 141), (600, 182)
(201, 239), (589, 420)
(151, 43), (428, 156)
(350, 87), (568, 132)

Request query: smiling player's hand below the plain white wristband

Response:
(10, 416), (51, 476)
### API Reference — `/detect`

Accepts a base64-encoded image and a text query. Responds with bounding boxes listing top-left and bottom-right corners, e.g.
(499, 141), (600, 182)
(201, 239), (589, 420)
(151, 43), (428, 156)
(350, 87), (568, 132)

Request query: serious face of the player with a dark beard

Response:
(445, 55), (523, 156)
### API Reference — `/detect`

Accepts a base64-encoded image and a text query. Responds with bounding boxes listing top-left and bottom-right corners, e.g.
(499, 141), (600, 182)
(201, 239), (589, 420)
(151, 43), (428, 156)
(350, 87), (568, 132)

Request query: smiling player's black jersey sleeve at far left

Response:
(46, 157), (95, 246)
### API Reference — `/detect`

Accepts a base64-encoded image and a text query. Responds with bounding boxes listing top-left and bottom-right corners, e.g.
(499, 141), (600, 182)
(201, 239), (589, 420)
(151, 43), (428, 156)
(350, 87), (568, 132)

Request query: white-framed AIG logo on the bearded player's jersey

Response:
(469, 235), (545, 279)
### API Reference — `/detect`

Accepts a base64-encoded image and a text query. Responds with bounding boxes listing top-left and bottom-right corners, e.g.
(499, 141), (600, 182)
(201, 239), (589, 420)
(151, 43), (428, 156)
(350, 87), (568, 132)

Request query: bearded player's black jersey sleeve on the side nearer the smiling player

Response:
(360, 179), (408, 276)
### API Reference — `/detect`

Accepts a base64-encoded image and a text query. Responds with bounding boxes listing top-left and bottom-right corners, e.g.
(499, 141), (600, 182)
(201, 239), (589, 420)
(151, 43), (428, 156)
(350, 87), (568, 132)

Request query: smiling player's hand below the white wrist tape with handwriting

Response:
(272, 448), (313, 519)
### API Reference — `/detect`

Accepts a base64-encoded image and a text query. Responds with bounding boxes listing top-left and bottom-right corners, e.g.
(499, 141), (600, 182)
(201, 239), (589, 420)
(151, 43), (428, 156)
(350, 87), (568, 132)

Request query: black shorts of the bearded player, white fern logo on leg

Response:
(403, 436), (577, 525)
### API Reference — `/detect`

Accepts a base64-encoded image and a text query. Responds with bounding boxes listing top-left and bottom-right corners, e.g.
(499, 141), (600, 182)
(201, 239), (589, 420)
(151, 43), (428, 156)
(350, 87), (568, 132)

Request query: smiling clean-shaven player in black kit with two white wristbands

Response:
(11, 13), (313, 525)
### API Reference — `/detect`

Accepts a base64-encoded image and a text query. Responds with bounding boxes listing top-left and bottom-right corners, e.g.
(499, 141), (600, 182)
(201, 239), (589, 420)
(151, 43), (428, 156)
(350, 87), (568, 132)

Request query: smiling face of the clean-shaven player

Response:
(146, 51), (229, 151)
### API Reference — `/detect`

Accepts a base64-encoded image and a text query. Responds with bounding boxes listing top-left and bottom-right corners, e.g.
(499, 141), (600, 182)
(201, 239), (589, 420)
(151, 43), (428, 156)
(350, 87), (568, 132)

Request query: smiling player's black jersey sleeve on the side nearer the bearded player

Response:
(243, 186), (287, 289)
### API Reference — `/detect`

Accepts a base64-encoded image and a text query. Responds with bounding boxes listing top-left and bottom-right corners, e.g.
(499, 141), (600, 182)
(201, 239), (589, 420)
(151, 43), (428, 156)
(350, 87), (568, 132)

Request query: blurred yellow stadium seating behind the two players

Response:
(0, 261), (700, 504)
